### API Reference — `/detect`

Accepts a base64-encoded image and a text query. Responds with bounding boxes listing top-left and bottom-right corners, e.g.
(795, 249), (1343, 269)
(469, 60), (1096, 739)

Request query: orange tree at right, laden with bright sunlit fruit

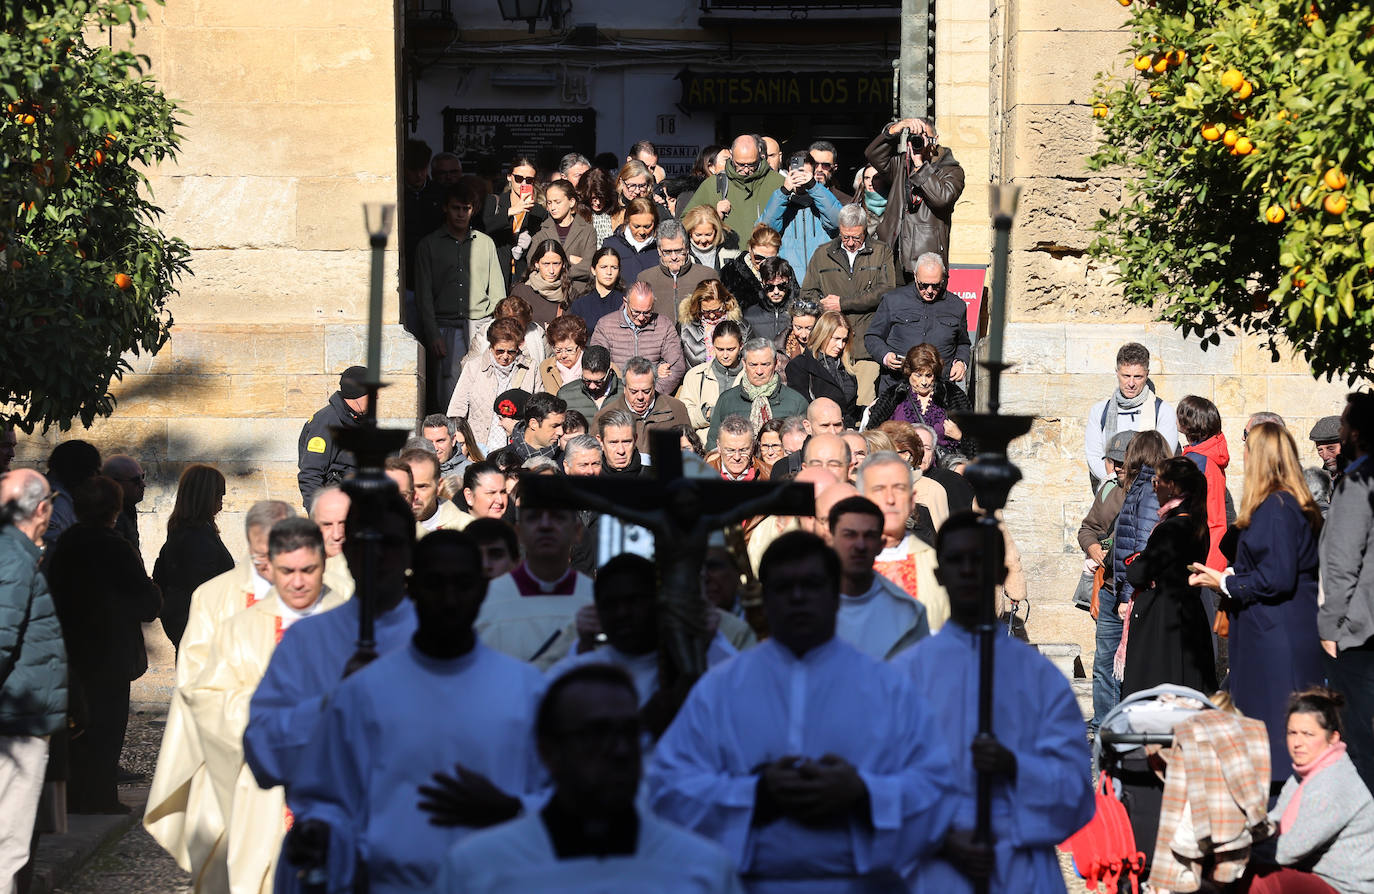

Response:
(1090, 0), (1374, 378)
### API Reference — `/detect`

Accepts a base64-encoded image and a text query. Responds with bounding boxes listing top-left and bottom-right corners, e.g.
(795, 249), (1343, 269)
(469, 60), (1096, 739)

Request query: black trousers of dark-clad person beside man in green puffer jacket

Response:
(67, 673), (129, 813)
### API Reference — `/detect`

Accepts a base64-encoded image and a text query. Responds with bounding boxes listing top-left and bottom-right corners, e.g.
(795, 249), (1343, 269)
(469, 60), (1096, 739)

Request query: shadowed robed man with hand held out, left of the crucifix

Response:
(276, 531), (544, 894)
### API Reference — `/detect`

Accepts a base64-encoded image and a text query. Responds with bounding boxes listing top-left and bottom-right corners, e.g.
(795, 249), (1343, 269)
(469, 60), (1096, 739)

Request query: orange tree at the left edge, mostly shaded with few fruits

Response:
(0, 0), (188, 431)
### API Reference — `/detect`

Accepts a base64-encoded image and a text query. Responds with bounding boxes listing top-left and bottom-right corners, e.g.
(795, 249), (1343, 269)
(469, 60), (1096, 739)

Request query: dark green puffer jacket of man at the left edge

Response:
(0, 525), (67, 736)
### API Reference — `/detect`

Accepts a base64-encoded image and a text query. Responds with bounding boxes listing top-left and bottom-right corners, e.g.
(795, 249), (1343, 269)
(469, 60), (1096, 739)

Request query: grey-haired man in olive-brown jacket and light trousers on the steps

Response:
(801, 205), (897, 405)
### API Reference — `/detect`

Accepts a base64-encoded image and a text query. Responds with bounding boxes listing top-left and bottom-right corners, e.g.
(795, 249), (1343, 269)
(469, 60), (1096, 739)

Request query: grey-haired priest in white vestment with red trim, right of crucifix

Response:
(855, 450), (949, 633)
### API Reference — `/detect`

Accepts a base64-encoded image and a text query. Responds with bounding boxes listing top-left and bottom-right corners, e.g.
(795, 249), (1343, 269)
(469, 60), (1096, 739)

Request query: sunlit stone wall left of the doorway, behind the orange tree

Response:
(18, 0), (418, 567)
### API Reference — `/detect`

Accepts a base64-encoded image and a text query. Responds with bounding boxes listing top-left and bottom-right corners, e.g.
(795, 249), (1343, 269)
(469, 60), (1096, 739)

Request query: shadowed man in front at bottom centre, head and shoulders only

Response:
(433, 661), (741, 894)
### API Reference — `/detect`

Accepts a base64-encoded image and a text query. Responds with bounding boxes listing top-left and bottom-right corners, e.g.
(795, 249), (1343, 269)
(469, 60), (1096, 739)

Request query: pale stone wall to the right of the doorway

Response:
(983, 0), (1347, 656)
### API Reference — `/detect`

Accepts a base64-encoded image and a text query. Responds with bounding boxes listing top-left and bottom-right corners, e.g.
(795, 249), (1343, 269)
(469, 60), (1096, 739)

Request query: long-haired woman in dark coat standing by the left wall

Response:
(153, 463), (234, 647)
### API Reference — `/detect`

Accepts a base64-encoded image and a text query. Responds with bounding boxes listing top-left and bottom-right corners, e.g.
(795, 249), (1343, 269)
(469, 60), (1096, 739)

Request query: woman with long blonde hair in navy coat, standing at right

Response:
(1189, 422), (1325, 781)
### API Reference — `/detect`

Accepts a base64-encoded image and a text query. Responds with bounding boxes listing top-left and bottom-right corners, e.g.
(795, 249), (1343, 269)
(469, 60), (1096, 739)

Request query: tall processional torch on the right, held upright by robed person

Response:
(958, 184), (1035, 894)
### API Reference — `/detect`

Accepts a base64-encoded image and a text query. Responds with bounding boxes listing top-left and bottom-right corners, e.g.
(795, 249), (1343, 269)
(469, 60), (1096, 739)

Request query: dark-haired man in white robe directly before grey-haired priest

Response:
(827, 496), (930, 659)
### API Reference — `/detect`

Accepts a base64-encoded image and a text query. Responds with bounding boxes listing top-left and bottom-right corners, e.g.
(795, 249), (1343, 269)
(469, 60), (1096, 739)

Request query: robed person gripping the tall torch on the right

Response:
(892, 512), (1094, 894)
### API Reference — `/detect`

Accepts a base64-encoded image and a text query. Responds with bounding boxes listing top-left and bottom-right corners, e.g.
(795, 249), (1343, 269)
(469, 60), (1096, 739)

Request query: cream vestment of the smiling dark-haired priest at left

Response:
(183, 588), (344, 894)
